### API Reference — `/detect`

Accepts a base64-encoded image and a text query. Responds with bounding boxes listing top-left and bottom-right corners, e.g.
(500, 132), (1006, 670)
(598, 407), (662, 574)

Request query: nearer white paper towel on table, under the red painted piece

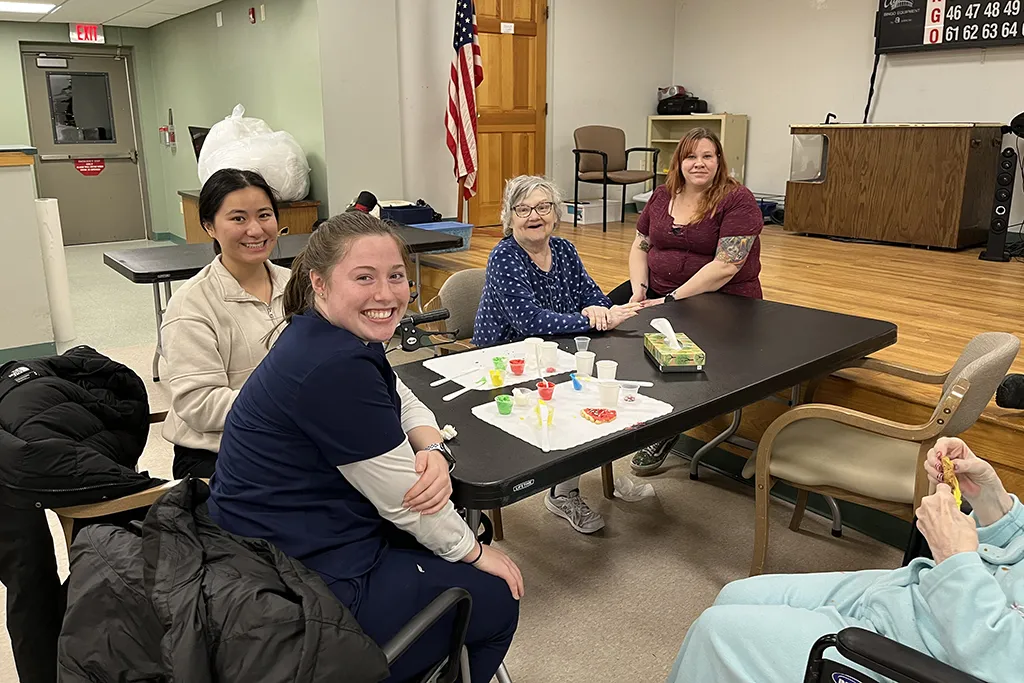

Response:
(472, 382), (672, 451)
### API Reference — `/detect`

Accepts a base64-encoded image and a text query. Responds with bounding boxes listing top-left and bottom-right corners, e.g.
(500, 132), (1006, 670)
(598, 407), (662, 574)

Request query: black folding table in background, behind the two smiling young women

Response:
(103, 225), (462, 382)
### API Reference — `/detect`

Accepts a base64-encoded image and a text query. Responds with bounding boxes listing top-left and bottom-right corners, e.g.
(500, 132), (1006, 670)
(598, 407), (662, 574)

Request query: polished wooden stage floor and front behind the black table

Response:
(415, 221), (1024, 493)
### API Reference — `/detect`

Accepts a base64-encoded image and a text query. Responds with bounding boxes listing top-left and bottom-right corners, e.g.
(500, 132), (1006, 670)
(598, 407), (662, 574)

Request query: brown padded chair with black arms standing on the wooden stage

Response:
(572, 126), (660, 232)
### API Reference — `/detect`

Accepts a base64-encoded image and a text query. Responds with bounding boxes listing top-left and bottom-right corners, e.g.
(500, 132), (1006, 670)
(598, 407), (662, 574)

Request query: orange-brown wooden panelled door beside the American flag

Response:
(469, 0), (548, 225)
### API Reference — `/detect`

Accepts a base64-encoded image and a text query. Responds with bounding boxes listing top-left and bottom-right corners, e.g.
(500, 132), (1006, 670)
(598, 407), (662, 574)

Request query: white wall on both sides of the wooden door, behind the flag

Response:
(387, 0), (676, 216)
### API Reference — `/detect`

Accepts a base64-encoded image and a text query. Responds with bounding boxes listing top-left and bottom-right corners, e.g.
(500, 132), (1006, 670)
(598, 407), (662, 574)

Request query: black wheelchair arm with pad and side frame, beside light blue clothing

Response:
(804, 629), (984, 683)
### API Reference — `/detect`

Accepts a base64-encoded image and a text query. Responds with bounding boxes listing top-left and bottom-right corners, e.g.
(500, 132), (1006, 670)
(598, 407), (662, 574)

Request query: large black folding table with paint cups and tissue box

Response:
(395, 294), (896, 522)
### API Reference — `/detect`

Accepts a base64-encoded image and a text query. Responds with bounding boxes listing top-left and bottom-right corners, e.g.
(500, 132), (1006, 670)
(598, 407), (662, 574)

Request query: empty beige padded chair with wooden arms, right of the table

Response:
(743, 332), (1020, 575)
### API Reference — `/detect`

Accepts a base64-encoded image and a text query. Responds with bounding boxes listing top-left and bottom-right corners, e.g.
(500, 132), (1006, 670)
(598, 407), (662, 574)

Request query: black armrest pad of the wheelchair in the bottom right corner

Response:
(836, 629), (984, 683)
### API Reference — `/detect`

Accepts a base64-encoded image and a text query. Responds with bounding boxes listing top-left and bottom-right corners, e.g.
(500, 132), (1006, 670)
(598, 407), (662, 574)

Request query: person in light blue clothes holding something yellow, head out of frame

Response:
(669, 438), (1024, 683)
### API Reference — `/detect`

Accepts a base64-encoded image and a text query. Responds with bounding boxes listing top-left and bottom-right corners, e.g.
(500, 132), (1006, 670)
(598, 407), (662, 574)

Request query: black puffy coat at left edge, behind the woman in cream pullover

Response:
(0, 346), (159, 508)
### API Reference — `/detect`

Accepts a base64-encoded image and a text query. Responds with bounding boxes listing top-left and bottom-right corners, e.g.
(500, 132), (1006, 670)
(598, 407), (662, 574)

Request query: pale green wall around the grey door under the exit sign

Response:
(0, 22), (167, 241)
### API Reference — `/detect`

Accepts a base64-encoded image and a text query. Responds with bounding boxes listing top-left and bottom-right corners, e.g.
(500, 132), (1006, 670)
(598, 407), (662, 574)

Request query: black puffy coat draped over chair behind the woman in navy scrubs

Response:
(58, 478), (388, 683)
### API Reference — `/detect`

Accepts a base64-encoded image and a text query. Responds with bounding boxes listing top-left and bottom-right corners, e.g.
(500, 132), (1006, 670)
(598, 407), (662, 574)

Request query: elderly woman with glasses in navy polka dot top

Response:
(473, 175), (642, 533)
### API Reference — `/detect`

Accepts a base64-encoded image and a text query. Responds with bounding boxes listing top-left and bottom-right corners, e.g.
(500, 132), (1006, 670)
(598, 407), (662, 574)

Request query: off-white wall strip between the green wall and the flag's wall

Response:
(316, 0), (403, 213)
